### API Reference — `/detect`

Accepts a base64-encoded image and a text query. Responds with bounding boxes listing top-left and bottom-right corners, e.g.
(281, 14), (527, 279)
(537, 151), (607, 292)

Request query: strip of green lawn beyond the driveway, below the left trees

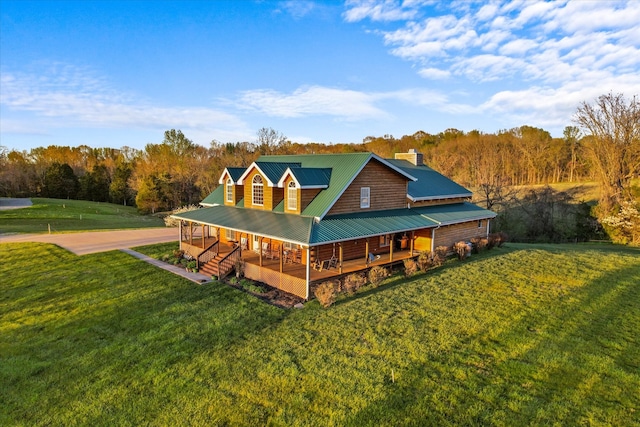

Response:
(0, 198), (164, 233)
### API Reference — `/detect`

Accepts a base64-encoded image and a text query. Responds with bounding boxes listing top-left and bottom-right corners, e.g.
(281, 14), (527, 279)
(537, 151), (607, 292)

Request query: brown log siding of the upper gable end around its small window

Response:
(328, 160), (408, 215)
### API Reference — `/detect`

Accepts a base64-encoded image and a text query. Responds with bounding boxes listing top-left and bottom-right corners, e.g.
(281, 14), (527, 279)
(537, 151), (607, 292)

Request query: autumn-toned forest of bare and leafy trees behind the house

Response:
(0, 93), (640, 244)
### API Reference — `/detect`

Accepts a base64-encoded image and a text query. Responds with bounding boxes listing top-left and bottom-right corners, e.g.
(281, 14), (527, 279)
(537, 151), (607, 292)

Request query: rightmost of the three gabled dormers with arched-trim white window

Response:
(278, 167), (331, 214)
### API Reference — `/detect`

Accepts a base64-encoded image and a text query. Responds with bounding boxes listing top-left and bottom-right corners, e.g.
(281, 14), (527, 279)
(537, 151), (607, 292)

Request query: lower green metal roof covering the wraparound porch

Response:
(173, 202), (496, 246)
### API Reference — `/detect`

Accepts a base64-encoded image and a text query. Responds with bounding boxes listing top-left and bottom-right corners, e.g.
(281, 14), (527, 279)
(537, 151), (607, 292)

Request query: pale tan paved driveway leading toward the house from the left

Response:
(0, 227), (178, 255)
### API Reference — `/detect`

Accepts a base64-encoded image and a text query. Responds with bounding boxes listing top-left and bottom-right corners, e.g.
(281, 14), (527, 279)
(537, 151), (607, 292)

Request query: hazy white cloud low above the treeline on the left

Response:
(0, 64), (244, 137)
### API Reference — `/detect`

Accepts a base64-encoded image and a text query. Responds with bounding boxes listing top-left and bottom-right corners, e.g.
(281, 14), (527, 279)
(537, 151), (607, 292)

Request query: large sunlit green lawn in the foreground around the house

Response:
(0, 244), (640, 426)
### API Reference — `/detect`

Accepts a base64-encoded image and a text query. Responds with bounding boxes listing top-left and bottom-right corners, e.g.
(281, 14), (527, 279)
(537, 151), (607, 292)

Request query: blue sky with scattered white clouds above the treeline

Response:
(0, 0), (640, 150)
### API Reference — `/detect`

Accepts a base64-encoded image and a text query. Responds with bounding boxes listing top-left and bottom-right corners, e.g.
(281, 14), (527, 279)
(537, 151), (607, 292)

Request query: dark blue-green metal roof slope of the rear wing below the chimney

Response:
(387, 159), (472, 201)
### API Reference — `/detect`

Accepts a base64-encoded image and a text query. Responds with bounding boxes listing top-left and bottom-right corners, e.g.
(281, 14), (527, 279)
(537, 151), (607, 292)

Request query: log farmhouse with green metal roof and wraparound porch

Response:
(174, 150), (495, 299)
